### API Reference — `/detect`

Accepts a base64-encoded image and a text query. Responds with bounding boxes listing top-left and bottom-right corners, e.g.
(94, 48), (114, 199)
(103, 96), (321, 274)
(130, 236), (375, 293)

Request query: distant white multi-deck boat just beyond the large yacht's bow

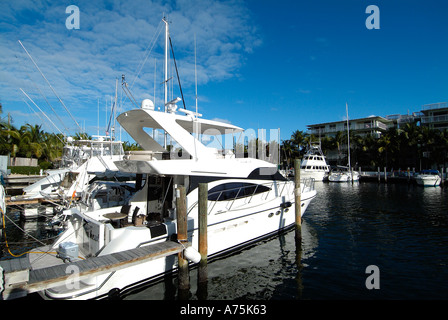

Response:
(300, 143), (330, 181)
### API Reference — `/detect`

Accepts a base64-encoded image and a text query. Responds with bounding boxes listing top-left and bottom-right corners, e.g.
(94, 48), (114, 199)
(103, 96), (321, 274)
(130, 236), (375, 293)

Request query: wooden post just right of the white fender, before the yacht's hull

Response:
(198, 183), (208, 300)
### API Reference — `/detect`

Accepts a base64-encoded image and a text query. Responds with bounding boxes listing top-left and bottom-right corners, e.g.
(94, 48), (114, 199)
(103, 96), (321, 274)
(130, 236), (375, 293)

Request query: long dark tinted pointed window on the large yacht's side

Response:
(208, 182), (271, 201)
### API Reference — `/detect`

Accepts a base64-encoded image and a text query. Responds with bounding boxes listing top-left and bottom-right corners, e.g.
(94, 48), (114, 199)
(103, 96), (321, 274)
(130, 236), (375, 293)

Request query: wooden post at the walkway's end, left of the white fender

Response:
(176, 186), (190, 300)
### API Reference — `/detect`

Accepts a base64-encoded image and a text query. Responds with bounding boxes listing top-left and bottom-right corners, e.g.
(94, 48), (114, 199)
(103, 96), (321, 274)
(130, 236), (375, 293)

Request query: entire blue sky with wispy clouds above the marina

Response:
(0, 0), (448, 140)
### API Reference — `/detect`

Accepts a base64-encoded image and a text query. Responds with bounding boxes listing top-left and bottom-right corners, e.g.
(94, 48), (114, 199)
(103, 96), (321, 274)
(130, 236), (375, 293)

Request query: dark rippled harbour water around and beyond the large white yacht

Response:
(1, 182), (448, 300)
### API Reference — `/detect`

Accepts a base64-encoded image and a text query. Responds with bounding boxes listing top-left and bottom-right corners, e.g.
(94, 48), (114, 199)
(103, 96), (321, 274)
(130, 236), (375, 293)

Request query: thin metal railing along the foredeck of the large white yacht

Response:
(188, 178), (315, 214)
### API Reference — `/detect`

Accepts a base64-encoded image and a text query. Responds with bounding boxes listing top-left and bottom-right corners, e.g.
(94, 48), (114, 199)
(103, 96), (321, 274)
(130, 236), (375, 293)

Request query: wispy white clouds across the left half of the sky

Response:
(0, 0), (261, 134)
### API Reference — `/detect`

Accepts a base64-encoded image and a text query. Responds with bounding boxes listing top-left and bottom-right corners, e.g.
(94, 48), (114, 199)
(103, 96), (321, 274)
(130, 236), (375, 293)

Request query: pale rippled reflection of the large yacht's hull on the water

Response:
(125, 222), (317, 300)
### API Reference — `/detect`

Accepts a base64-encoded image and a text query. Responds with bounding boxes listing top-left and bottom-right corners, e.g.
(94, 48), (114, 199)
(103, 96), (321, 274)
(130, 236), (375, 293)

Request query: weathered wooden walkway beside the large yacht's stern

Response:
(0, 241), (183, 299)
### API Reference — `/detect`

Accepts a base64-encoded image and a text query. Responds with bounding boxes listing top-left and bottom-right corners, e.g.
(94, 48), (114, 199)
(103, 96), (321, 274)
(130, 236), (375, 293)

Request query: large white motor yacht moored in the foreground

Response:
(29, 20), (316, 299)
